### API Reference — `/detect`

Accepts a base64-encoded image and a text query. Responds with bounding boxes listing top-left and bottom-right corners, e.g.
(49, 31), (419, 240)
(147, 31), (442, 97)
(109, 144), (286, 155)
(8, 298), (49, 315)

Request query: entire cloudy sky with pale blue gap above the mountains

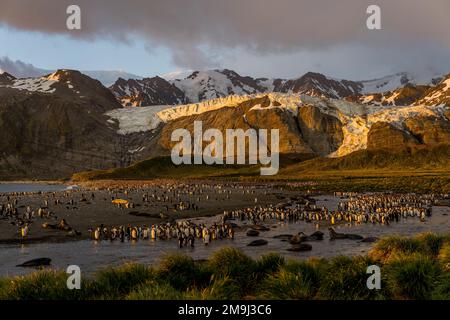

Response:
(0, 0), (450, 80)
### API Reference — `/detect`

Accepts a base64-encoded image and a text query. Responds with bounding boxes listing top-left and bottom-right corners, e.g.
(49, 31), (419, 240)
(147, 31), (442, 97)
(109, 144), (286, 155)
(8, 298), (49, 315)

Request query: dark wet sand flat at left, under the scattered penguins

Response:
(0, 180), (298, 244)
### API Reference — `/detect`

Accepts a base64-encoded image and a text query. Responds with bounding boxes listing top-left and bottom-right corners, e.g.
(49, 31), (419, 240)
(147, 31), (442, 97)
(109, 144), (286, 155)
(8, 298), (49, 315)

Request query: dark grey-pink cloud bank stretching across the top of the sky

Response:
(0, 0), (450, 75)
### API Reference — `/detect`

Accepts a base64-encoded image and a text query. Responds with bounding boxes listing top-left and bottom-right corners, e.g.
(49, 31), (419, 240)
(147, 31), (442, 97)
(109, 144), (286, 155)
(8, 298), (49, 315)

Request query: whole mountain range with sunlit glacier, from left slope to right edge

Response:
(0, 66), (450, 179)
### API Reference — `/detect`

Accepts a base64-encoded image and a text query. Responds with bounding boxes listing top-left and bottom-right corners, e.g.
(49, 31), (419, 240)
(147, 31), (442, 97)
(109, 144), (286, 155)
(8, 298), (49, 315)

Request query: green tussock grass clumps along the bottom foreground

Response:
(0, 233), (450, 300)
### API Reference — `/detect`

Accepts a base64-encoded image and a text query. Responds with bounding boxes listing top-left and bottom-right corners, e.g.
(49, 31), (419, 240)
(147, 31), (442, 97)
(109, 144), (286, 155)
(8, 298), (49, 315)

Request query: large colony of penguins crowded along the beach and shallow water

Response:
(0, 182), (448, 247)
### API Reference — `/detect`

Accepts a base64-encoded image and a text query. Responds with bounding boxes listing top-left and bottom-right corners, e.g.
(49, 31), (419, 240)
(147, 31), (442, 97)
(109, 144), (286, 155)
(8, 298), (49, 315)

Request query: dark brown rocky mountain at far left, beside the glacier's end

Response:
(0, 70), (153, 180)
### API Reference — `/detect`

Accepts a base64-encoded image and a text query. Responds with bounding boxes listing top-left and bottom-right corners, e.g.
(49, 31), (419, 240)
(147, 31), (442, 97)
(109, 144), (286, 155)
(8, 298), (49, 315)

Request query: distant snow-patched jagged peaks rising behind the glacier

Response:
(110, 69), (442, 106)
